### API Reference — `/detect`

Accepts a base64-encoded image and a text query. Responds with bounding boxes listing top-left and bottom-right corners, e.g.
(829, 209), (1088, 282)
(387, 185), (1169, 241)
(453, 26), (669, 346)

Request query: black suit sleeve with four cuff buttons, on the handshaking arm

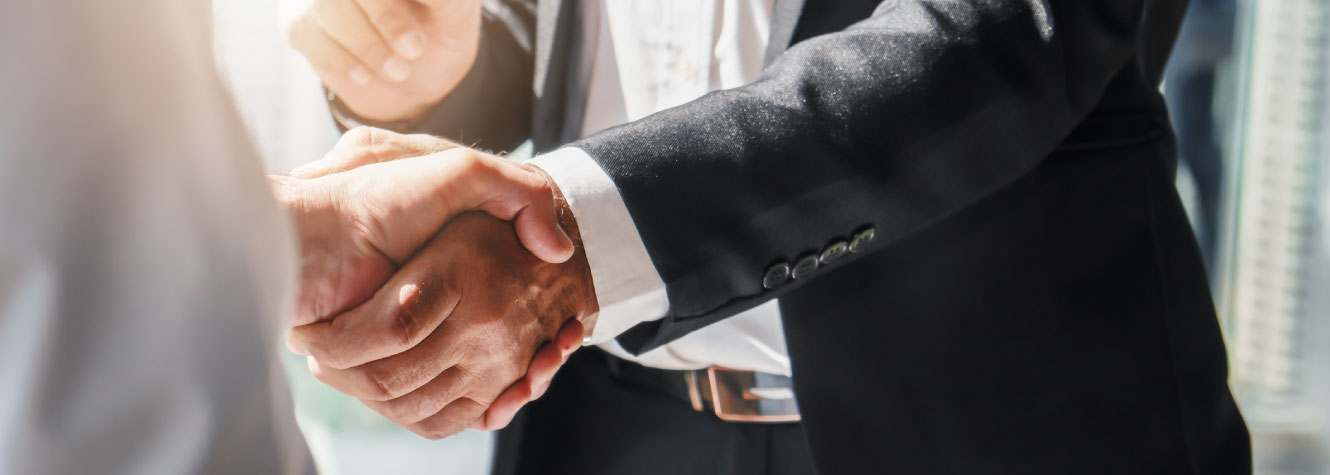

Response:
(573, 0), (1152, 353)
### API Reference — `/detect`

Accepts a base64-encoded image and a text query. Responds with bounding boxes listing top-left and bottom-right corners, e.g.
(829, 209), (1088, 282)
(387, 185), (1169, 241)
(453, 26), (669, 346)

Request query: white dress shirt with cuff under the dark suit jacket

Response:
(532, 0), (790, 375)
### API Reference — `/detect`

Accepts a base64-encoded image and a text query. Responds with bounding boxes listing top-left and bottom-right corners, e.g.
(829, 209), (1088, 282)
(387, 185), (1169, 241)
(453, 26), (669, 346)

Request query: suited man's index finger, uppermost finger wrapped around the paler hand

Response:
(291, 250), (460, 369)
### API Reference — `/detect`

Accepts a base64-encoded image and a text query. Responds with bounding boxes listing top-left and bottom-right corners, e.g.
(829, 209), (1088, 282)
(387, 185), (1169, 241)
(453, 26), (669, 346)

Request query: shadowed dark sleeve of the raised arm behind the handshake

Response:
(330, 0), (536, 150)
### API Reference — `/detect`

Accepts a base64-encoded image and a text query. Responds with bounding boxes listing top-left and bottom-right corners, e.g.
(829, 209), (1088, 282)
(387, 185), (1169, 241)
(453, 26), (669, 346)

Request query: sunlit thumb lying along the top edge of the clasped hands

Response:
(290, 126), (460, 180)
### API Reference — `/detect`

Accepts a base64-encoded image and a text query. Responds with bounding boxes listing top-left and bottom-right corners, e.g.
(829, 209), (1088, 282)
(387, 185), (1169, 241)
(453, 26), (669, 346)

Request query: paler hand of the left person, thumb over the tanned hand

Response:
(271, 128), (573, 325)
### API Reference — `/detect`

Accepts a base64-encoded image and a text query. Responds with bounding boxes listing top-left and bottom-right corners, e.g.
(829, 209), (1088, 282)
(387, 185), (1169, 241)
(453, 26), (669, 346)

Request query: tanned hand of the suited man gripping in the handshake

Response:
(290, 213), (599, 439)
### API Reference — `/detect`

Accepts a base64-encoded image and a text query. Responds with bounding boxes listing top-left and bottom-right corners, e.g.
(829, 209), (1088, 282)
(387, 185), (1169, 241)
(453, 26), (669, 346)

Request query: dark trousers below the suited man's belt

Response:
(493, 349), (815, 475)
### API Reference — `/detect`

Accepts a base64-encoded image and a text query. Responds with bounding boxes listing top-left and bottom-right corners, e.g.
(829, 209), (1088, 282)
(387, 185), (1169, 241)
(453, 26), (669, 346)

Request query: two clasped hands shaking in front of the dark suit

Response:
(270, 128), (599, 439)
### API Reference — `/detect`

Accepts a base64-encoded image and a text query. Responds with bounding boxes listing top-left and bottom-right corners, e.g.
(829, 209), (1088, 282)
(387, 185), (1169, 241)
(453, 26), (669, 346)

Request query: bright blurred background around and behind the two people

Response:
(213, 0), (1330, 475)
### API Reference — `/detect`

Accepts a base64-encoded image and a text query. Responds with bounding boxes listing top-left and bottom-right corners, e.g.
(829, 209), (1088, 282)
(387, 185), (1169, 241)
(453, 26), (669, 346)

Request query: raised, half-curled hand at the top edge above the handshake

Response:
(282, 0), (480, 122)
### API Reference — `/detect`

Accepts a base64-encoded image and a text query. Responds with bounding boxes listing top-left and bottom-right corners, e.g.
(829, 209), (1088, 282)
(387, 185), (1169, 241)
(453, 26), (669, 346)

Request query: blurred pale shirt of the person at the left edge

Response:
(0, 0), (314, 475)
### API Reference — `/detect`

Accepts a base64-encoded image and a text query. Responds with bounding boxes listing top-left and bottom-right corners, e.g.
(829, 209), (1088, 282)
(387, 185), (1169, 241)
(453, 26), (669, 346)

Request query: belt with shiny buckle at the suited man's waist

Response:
(600, 351), (799, 423)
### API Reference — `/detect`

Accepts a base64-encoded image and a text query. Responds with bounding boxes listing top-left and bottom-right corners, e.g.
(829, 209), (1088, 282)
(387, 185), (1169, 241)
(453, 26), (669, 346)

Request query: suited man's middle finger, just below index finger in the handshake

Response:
(306, 321), (463, 399)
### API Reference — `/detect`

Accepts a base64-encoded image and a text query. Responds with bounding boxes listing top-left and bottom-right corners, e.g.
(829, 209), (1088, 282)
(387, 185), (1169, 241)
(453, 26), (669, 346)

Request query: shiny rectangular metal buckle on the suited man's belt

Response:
(688, 366), (799, 423)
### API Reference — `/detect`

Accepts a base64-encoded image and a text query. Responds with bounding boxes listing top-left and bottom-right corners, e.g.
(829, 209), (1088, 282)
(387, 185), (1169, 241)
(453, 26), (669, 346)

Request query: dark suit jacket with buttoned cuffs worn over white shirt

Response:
(340, 0), (1250, 475)
